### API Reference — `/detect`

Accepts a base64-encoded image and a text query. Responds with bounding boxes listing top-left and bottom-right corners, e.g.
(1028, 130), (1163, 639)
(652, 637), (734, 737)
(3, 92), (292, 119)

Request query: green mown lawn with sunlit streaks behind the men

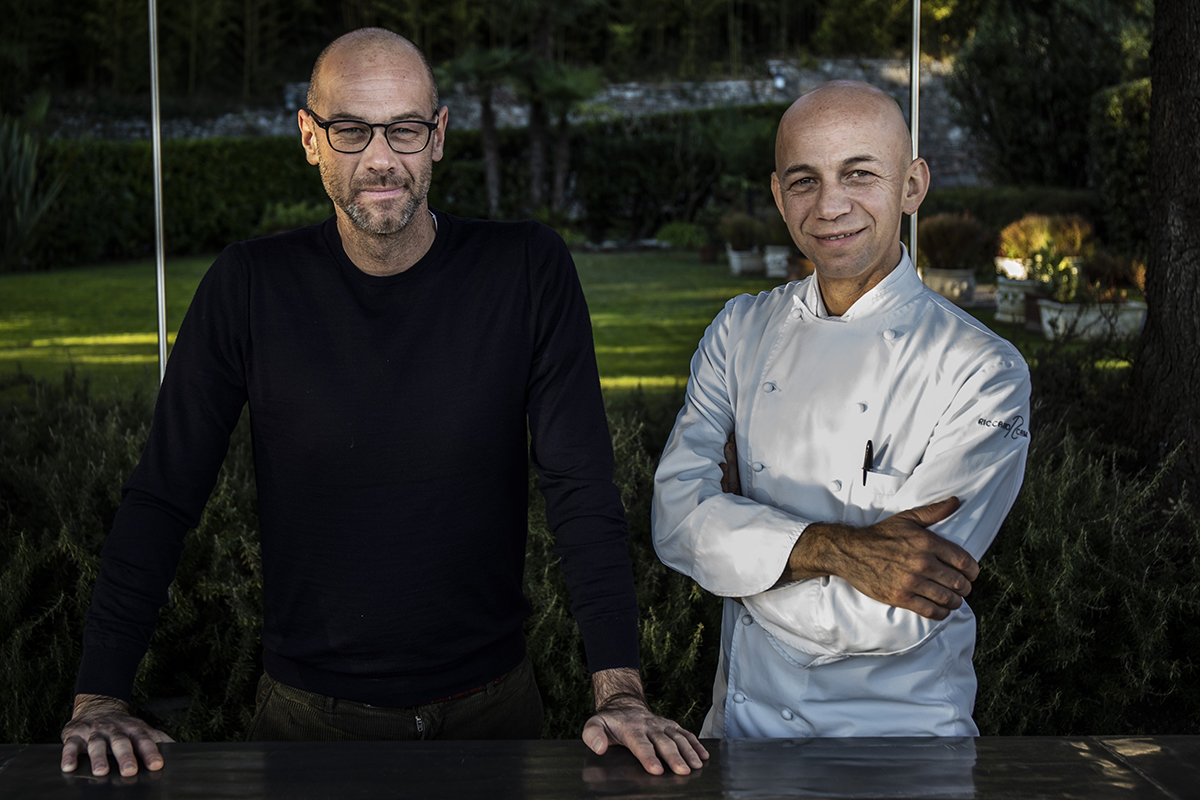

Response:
(0, 252), (1040, 393)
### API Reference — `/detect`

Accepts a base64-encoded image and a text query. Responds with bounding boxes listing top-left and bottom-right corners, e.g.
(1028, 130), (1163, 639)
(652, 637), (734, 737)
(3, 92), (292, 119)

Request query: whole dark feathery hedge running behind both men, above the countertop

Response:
(0, 350), (1200, 742)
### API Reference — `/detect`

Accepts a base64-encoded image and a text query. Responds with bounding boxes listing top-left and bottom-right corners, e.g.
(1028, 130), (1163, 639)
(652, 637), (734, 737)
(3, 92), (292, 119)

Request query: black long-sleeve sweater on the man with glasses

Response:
(77, 212), (637, 706)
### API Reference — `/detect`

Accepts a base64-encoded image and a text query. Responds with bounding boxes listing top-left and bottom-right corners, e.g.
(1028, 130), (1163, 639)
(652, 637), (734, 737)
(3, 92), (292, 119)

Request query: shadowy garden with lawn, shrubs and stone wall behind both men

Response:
(0, 0), (1200, 741)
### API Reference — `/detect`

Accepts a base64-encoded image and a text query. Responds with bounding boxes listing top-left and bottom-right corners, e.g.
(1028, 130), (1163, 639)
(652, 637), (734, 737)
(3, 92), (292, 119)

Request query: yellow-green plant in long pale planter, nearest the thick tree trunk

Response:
(1034, 253), (1146, 339)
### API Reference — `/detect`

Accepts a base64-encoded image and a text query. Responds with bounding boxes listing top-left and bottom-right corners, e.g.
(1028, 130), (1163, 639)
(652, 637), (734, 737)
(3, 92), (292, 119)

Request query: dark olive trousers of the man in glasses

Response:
(247, 657), (542, 741)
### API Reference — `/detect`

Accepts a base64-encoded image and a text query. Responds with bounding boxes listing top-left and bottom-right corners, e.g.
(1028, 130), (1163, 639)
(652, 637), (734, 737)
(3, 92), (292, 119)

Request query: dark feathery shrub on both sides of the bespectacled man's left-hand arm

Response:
(0, 374), (262, 741)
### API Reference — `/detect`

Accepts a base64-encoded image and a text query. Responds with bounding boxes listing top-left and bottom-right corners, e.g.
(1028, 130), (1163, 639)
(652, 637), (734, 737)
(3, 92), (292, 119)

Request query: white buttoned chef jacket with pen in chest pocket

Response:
(653, 251), (1030, 738)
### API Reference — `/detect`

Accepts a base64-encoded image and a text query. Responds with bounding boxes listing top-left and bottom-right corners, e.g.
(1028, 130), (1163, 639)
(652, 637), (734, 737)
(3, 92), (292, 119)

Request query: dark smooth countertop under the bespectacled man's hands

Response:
(0, 736), (1200, 800)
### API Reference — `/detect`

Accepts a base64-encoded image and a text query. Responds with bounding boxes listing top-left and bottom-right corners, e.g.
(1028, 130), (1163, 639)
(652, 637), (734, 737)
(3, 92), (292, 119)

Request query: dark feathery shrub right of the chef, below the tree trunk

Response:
(971, 422), (1200, 735)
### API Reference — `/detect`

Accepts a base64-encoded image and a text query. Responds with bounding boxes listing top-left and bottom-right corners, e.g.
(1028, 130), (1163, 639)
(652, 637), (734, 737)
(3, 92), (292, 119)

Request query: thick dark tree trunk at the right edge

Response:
(1130, 0), (1200, 494)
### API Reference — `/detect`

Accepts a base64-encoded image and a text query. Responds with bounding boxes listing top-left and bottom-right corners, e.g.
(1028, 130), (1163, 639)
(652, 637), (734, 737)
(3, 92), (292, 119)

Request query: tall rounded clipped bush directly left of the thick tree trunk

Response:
(1087, 78), (1150, 255)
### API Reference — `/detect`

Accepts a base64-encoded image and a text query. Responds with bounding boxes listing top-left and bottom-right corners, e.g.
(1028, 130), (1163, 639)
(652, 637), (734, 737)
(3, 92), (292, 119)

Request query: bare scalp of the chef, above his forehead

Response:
(775, 80), (912, 169)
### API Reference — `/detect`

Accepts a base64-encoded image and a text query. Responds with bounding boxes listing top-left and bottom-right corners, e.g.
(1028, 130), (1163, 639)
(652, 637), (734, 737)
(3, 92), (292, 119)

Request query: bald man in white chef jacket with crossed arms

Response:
(653, 82), (1030, 738)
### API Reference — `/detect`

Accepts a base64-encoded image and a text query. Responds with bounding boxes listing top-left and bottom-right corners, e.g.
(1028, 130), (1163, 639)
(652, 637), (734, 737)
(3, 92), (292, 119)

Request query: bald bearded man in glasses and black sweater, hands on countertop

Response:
(62, 29), (707, 775)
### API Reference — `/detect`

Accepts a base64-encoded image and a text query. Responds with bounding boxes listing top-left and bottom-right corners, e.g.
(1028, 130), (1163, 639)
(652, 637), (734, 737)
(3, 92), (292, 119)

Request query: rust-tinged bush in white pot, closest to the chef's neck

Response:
(917, 213), (986, 306)
